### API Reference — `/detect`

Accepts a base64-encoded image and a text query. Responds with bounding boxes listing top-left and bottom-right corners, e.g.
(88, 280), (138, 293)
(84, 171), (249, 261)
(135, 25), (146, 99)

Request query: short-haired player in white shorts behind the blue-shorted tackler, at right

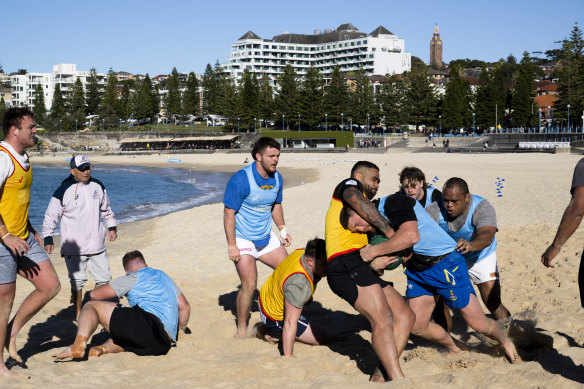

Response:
(426, 177), (511, 319)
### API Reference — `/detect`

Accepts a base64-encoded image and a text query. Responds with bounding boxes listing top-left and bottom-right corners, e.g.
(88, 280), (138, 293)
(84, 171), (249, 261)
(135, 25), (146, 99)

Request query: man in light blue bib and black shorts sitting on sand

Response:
(53, 251), (191, 359)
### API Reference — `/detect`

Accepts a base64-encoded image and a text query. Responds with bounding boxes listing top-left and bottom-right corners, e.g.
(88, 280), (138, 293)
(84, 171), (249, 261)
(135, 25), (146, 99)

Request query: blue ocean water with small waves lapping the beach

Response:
(29, 163), (232, 233)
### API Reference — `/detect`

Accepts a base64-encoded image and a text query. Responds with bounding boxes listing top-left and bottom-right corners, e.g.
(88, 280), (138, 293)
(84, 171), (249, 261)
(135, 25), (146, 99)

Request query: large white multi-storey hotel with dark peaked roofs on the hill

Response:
(224, 23), (412, 82)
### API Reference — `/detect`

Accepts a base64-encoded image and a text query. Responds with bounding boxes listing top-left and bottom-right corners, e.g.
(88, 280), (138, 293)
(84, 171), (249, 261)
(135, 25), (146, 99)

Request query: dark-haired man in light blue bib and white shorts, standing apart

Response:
(223, 137), (292, 338)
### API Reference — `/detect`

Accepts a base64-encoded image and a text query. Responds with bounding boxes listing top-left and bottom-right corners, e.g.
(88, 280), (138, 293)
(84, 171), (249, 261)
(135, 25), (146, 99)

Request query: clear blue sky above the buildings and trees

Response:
(0, 0), (584, 76)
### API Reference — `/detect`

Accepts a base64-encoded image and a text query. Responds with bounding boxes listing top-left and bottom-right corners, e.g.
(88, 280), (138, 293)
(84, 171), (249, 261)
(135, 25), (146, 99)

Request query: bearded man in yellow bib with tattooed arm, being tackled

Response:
(325, 161), (416, 382)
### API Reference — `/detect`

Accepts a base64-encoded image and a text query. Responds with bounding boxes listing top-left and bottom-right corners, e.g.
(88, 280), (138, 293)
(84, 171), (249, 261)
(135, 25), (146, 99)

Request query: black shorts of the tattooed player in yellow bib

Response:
(326, 251), (393, 308)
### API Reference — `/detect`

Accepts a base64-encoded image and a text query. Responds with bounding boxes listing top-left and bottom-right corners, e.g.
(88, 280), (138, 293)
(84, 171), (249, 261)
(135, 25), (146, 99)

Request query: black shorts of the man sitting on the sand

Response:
(110, 304), (171, 355)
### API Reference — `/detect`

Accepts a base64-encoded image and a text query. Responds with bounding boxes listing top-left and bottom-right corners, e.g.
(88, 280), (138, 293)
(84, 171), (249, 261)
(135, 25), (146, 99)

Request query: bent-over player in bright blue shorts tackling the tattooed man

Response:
(341, 197), (515, 361)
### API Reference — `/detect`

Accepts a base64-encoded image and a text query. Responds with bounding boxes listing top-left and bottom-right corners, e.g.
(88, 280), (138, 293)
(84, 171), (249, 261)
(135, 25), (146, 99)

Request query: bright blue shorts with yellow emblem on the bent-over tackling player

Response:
(405, 251), (476, 309)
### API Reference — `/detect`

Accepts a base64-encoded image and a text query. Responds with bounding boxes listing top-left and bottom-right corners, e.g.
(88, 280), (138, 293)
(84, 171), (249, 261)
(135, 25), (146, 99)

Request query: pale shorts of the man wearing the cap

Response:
(65, 251), (112, 290)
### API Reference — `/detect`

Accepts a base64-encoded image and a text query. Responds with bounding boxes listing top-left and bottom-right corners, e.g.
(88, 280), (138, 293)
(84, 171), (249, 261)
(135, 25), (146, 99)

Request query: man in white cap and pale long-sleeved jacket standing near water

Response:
(42, 155), (117, 317)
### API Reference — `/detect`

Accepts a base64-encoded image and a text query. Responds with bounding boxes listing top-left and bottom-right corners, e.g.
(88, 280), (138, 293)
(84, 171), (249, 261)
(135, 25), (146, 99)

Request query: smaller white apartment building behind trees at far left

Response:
(10, 63), (107, 111)
